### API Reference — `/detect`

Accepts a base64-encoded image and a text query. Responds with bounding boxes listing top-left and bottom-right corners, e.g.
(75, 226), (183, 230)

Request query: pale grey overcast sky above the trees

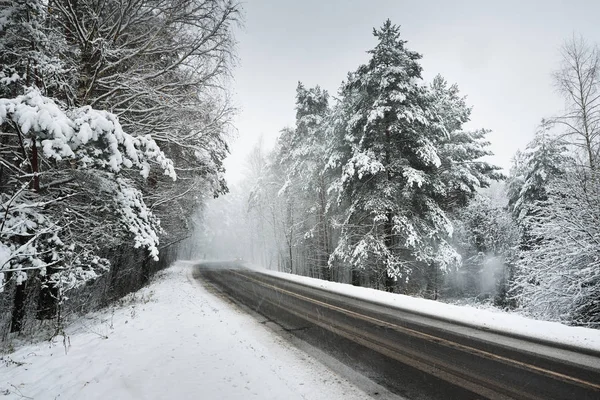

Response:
(226, 0), (600, 181)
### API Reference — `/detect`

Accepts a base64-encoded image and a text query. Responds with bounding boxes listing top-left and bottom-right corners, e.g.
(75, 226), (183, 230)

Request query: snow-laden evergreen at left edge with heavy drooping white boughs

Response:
(0, 89), (176, 296)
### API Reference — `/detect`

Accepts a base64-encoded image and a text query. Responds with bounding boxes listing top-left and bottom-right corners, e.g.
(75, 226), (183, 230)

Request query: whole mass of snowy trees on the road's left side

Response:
(0, 0), (240, 336)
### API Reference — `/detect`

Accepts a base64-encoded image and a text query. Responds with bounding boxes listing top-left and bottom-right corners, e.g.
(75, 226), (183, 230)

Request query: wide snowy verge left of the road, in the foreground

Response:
(0, 262), (368, 400)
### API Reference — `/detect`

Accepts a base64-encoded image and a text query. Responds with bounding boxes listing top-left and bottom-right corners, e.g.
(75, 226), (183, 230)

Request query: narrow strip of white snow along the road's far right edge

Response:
(255, 265), (600, 351)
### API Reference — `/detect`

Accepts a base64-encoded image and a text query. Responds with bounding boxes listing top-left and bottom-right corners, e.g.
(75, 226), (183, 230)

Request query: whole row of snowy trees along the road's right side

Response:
(204, 21), (600, 326)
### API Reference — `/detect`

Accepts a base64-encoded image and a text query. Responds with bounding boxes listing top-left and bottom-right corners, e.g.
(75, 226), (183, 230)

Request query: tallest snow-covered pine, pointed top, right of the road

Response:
(330, 20), (432, 290)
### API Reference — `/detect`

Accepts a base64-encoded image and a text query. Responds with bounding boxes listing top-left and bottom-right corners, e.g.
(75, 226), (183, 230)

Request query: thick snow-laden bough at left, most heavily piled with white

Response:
(0, 89), (177, 180)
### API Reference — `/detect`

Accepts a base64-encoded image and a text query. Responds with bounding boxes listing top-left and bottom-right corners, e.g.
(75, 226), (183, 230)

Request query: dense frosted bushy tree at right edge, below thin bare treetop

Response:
(513, 168), (600, 327)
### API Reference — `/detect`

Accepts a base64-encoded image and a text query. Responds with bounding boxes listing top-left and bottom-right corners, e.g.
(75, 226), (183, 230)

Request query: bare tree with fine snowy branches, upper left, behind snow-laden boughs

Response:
(47, 0), (240, 240)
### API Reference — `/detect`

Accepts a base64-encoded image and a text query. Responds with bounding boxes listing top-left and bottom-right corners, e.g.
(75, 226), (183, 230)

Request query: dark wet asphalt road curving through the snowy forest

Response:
(194, 263), (600, 400)
